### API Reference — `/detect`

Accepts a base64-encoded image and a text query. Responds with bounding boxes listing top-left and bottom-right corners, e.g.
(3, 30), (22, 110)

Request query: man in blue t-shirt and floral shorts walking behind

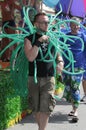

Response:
(63, 17), (86, 123)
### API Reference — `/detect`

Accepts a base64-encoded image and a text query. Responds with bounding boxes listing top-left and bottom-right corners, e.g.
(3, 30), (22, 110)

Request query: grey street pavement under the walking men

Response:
(6, 87), (86, 130)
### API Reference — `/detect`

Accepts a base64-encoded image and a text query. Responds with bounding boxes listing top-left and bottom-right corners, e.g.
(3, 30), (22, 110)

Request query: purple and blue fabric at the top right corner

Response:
(56, 0), (86, 18)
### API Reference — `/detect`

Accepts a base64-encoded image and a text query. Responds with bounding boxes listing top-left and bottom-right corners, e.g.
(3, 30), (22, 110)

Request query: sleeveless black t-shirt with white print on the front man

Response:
(26, 33), (55, 77)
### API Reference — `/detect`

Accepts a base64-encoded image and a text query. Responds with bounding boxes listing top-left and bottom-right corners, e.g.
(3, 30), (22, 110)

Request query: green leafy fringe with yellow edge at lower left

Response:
(0, 70), (28, 130)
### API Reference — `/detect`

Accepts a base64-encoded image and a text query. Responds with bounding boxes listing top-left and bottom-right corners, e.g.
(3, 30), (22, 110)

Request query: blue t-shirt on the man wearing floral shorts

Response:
(64, 32), (84, 68)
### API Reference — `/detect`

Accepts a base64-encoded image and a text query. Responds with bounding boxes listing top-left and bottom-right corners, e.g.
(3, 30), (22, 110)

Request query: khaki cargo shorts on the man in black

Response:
(28, 76), (56, 113)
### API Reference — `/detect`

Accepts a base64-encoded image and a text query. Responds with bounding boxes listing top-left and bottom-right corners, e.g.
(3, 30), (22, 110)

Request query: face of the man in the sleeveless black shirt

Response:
(35, 15), (49, 32)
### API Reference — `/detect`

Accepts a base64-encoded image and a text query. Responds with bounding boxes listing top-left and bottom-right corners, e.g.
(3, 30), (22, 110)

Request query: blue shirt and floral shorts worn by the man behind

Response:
(63, 32), (85, 107)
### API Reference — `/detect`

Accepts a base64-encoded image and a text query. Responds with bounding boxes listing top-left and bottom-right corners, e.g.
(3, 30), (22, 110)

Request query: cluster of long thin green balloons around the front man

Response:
(0, 7), (84, 92)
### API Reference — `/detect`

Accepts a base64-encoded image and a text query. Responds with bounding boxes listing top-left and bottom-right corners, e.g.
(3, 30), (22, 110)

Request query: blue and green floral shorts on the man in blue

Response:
(63, 68), (83, 107)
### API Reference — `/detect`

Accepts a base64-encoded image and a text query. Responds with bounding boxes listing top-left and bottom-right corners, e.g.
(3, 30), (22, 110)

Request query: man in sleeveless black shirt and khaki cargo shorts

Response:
(24, 13), (63, 130)
